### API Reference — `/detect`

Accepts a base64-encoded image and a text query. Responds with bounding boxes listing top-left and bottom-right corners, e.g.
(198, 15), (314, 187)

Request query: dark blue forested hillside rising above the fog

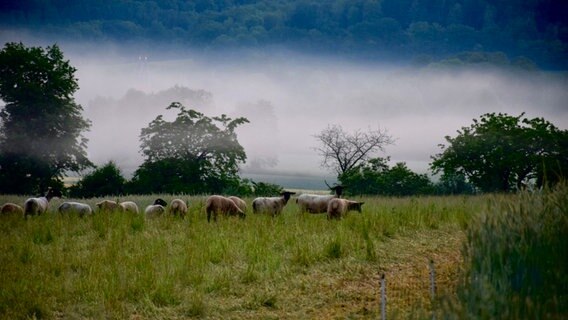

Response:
(0, 0), (568, 69)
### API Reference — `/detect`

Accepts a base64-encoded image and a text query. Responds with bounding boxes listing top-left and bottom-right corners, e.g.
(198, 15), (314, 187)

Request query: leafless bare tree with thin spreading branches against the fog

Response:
(314, 125), (394, 176)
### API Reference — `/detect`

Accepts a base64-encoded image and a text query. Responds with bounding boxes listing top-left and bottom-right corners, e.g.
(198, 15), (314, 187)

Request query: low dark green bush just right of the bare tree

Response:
(339, 158), (434, 196)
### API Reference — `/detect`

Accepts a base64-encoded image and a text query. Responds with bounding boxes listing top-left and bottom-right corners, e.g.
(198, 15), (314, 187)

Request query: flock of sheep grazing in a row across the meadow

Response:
(0, 185), (363, 222)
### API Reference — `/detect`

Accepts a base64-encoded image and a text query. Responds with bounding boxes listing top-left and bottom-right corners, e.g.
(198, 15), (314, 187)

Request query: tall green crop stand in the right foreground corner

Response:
(454, 183), (568, 319)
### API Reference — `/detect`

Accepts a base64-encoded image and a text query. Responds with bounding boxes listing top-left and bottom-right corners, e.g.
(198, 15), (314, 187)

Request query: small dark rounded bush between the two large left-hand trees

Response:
(69, 161), (126, 198)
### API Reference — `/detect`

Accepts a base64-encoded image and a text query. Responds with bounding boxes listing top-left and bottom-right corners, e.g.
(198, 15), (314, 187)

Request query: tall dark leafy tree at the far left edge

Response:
(0, 43), (92, 193)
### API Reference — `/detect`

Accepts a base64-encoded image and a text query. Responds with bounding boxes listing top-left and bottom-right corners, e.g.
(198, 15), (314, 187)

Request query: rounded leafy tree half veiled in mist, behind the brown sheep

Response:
(131, 102), (248, 193)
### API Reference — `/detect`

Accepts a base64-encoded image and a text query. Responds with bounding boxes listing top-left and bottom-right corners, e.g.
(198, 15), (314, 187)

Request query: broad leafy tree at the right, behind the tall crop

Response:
(431, 113), (568, 192)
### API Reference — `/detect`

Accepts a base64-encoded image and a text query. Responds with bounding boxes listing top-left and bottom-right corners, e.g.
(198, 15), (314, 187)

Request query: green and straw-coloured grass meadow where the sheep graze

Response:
(0, 191), (552, 319)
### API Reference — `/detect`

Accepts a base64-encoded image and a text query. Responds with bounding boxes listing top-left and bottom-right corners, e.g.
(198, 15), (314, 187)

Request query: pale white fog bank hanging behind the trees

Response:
(15, 48), (568, 188)
